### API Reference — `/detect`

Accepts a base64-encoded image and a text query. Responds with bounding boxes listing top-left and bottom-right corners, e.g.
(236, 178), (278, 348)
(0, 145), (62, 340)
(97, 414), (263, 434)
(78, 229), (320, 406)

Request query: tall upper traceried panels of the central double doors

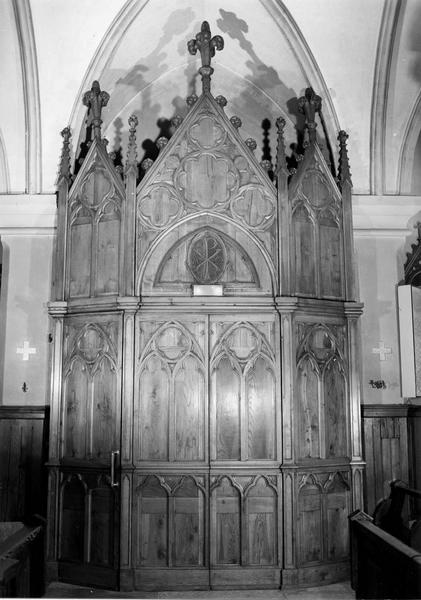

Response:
(136, 320), (276, 461)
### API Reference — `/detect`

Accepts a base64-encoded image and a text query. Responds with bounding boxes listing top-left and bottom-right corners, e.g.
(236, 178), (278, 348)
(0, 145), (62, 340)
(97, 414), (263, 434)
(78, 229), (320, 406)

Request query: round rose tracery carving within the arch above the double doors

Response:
(188, 233), (226, 285)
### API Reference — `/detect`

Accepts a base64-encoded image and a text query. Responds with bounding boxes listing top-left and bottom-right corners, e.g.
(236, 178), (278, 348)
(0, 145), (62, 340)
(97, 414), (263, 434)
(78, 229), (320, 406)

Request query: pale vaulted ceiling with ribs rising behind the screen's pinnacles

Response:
(0, 0), (421, 195)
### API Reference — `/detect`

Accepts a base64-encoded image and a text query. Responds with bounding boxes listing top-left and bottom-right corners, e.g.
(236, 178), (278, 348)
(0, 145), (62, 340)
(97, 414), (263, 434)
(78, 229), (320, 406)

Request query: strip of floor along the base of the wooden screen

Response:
(44, 582), (355, 600)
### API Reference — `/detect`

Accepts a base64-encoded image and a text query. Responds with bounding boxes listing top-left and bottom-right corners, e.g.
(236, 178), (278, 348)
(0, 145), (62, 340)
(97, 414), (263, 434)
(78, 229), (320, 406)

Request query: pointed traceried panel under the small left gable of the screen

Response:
(68, 149), (122, 298)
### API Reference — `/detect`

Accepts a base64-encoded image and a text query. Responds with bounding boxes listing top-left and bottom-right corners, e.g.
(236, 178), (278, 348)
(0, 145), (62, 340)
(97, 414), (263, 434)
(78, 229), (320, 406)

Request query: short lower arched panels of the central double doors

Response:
(133, 472), (282, 590)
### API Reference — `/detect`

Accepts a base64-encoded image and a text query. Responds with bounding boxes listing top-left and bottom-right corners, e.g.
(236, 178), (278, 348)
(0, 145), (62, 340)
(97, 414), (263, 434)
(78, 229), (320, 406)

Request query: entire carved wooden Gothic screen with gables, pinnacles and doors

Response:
(48, 22), (363, 590)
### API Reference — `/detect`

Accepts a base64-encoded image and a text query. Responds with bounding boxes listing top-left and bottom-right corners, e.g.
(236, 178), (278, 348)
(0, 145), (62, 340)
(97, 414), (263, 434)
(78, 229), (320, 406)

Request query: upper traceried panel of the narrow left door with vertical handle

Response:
(62, 317), (120, 461)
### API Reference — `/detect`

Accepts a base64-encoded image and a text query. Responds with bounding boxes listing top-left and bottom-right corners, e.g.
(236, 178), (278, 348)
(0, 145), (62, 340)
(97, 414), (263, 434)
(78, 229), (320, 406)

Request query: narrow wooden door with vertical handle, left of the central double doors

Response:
(58, 315), (121, 589)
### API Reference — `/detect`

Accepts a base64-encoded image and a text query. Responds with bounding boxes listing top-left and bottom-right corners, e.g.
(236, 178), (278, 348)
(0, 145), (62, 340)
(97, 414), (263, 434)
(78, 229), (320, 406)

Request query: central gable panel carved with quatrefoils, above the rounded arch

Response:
(137, 97), (277, 296)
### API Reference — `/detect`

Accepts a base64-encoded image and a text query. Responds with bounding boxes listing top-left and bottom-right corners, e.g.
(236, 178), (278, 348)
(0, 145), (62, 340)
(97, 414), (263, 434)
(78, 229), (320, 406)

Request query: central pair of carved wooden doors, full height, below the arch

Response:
(133, 314), (281, 589)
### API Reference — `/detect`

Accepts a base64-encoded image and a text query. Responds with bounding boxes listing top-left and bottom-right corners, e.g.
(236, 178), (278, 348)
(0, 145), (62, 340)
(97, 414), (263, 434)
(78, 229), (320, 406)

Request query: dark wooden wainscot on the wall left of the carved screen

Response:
(0, 406), (49, 521)
